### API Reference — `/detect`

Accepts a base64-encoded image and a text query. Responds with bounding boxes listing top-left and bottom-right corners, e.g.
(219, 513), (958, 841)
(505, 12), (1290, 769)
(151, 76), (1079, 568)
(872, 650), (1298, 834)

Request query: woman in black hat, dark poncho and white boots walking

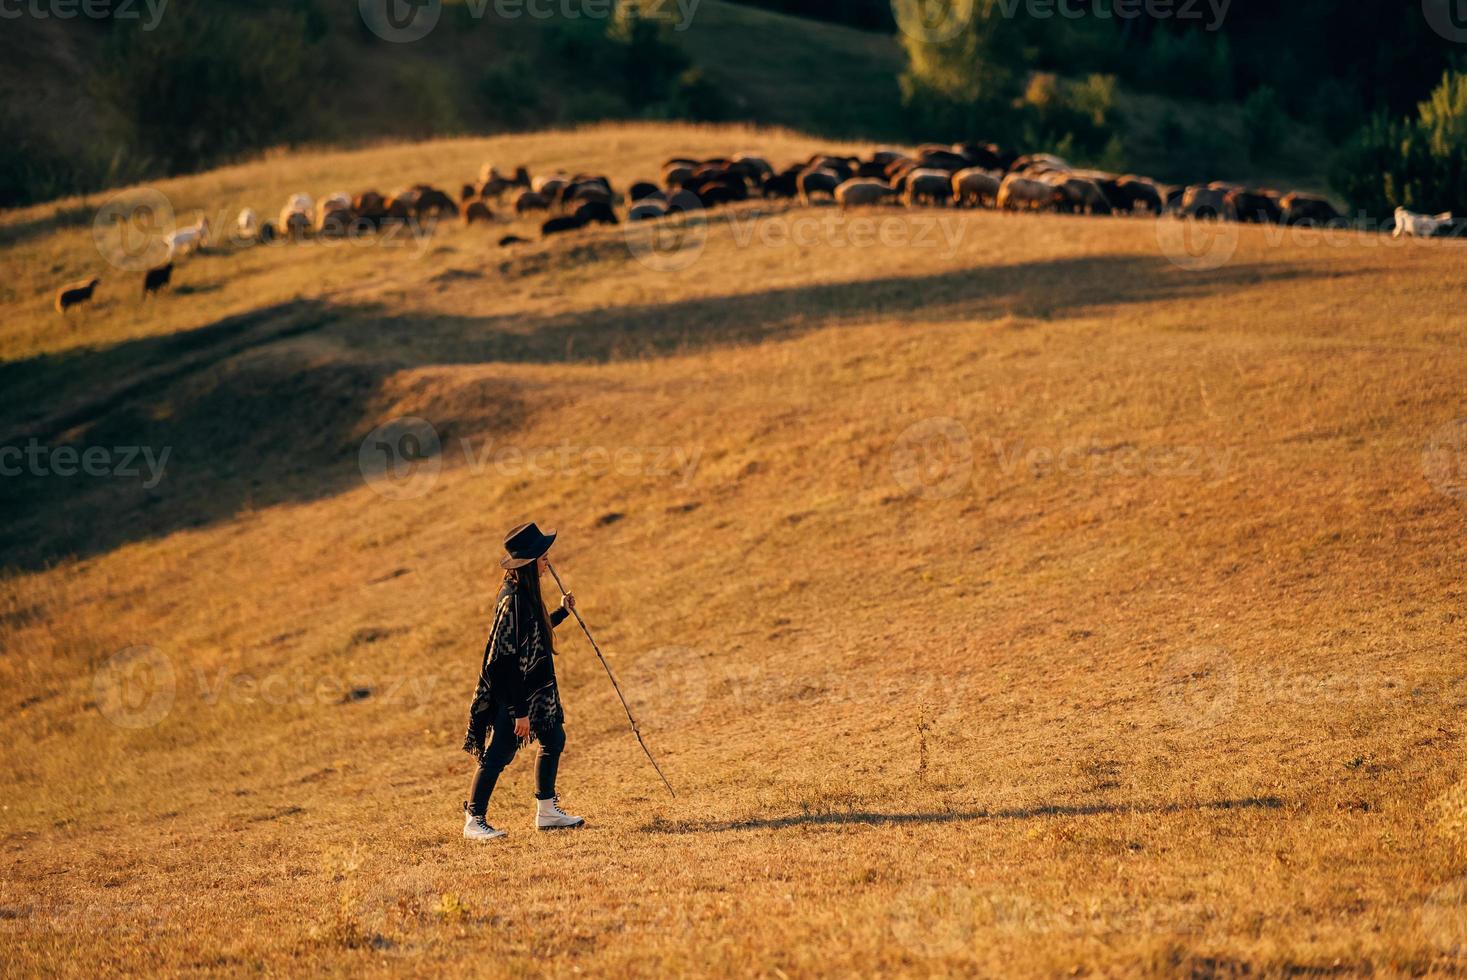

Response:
(464, 524), (585, 841)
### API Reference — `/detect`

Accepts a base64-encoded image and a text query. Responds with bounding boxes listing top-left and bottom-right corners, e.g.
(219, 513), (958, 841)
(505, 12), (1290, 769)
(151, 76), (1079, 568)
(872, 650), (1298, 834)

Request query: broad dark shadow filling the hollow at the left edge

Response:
(0, 302), (533, 569)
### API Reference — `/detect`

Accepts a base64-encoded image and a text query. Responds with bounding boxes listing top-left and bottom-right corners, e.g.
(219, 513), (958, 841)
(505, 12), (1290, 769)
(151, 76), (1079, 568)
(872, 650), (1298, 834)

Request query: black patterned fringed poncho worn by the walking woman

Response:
(464, 581), (566, 758)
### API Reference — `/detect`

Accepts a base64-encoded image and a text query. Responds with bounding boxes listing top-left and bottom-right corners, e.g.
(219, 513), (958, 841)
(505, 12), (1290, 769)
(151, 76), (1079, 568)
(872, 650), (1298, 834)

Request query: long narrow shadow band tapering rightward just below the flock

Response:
(318, 255), (1328, 362)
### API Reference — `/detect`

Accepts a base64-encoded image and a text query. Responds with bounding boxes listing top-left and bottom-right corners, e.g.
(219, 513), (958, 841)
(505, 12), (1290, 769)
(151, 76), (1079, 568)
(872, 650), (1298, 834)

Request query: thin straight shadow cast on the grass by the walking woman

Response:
(641, 797), (1284, 833)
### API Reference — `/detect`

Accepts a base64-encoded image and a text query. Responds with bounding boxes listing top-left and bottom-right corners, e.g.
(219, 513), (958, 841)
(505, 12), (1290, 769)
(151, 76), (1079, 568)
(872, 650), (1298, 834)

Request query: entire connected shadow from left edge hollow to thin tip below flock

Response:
(0, 252), (1319, 568)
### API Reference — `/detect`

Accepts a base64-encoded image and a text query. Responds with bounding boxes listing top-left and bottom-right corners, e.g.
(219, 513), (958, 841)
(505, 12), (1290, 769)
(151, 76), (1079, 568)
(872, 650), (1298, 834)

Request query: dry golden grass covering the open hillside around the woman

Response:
(0, 126), (1467, 977)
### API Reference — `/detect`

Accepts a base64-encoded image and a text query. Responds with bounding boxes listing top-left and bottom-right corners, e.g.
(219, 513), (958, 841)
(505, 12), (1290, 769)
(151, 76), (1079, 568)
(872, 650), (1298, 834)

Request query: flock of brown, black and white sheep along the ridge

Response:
(56, 135), (1454, 314)
